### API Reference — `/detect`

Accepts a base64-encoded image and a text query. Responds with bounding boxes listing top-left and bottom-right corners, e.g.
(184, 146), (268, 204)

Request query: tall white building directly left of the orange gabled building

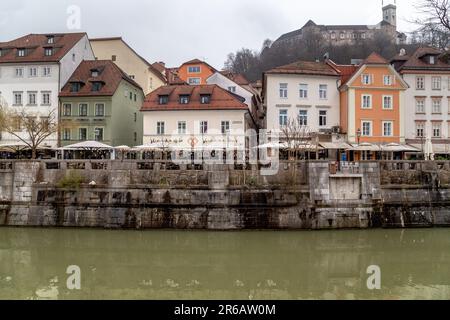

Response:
(263, 61), (340, 137)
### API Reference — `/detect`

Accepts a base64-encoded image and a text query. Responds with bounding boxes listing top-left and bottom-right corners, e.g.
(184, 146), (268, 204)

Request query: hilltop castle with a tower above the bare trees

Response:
(274, 4), (407, 46)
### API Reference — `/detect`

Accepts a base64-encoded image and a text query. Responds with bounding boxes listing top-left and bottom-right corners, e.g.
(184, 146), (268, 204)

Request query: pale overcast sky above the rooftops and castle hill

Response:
(0, 0), (420, 68)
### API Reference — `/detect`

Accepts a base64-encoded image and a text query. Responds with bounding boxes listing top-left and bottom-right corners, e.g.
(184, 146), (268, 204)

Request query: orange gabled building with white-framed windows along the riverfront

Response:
(334, 53), (408, 145)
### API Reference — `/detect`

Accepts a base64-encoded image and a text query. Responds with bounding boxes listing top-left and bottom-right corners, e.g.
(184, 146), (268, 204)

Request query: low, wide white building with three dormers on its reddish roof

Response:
(141, 85), (252, 148)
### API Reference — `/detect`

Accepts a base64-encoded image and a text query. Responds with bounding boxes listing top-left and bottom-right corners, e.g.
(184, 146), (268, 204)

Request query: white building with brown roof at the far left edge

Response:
(0, 33), (94, 147)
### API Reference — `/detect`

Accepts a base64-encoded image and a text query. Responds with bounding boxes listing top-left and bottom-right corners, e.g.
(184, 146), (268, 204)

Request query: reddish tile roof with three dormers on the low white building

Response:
(141, 85), (248, 111)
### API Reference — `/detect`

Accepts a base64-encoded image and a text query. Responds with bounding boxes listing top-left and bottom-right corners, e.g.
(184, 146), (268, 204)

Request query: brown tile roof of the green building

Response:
(59, 60), (142, 97)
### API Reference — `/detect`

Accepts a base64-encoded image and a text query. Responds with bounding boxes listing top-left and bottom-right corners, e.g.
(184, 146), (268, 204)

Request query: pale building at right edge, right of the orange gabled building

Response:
(392, 48), (450, 154)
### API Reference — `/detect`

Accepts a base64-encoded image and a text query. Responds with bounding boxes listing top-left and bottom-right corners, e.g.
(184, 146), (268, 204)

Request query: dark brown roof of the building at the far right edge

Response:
(399, 47), (450, 71)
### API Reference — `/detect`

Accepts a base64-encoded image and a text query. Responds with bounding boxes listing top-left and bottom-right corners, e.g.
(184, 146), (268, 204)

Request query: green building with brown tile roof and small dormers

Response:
(59, 60), (144, 146)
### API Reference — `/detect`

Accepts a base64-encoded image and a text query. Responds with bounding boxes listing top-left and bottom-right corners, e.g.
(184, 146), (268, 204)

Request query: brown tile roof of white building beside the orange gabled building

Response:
(266, 61), (339, 76)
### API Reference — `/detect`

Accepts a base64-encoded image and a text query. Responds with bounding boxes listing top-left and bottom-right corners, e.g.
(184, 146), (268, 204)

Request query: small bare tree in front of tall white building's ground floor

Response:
(281, 118), (312, 159)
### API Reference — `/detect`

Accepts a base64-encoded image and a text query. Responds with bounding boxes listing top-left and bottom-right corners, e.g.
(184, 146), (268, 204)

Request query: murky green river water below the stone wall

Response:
(0, 228), (450, 299)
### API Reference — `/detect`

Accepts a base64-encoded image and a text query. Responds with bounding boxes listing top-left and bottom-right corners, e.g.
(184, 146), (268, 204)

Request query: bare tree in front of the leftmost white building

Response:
(0, 101), (59, 159)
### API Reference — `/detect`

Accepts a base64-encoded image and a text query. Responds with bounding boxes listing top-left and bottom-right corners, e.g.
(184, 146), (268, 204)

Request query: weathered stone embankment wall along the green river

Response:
(0, 161), (450, 230)
